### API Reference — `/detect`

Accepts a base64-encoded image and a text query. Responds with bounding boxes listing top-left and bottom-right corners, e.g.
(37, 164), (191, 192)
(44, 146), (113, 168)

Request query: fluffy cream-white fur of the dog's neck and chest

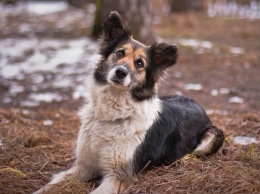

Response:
(76, 89), (160, 168)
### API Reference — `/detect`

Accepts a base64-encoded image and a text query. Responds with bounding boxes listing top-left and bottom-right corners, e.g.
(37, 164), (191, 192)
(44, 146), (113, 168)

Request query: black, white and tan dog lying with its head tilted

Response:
(35, 12), (224, 194)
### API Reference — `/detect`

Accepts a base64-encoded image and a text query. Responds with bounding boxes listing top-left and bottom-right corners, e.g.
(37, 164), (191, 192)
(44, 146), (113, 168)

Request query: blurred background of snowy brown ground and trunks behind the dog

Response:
(0, 0), (260, 115)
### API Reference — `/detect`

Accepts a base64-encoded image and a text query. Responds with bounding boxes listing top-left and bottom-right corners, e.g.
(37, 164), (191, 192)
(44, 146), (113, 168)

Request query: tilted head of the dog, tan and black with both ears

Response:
(95, 12), (178, 101)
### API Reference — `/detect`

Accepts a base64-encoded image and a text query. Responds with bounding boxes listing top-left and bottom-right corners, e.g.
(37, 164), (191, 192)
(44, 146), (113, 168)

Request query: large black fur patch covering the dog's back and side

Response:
(133, 96), (212, 173)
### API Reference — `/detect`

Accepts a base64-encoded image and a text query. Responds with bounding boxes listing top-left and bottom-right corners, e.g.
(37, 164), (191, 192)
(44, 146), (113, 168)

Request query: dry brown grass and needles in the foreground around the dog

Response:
(0, 109), (260, 193)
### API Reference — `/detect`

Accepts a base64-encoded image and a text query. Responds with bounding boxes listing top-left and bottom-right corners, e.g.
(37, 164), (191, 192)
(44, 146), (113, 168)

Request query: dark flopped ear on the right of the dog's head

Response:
(150, 43), (178, 70)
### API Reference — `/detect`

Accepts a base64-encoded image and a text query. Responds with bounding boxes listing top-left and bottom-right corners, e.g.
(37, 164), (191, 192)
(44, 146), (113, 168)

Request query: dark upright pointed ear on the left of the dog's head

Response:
(100, 11), (132, 57)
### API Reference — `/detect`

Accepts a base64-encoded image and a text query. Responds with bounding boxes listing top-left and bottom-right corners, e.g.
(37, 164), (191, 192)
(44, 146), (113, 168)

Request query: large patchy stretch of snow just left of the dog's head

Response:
(0, 38), (99, 106)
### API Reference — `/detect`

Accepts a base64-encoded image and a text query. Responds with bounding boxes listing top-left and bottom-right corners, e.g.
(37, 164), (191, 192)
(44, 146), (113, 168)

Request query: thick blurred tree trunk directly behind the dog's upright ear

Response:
(92, 0), (154, 43)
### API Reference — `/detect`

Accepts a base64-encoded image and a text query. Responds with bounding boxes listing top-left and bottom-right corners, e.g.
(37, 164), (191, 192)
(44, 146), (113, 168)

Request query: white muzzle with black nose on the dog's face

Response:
(107, 66), (131, 87)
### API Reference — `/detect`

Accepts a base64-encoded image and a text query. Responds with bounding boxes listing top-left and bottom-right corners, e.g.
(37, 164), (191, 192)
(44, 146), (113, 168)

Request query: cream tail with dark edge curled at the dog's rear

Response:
(192, 126), (225, 156)
